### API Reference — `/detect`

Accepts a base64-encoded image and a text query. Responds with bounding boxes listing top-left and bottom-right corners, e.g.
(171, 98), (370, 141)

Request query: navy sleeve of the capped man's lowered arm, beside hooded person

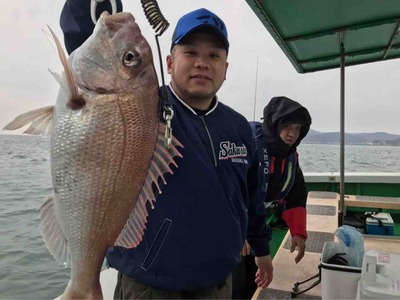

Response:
(247, 136), (272, 256)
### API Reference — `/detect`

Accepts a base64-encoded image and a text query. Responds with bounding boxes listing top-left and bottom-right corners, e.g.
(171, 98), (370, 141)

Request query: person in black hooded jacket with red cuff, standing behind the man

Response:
(233, 96), (311, 299)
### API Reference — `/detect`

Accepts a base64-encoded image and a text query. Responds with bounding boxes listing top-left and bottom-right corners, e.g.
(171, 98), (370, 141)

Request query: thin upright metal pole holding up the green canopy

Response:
(339, 32), (345, 226)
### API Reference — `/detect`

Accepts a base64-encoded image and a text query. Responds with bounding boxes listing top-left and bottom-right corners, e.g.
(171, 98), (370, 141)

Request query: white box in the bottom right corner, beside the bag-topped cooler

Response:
(357, 250), (400, 299)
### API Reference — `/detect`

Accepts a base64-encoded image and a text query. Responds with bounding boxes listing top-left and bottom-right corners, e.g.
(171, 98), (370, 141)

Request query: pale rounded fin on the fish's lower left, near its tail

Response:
(39, 195), (70, 266)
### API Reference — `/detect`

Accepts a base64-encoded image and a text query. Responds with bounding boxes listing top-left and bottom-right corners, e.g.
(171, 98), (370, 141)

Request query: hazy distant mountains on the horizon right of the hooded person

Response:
(303, 129), (400, 146)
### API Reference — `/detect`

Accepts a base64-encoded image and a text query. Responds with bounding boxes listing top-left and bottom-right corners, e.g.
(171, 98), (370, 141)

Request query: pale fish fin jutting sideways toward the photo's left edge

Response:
(3, 105), (54, 135)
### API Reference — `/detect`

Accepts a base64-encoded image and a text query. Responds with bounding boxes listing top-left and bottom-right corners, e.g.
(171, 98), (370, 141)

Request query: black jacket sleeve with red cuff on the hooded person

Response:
(282, 157), (307, 239)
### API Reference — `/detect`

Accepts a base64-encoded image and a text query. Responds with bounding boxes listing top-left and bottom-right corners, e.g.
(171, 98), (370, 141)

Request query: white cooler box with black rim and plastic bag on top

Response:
(321, 241), (361, 299)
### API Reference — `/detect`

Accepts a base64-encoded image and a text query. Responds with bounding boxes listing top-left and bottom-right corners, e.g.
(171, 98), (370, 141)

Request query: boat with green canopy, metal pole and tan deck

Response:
(246, 0), (400, 299)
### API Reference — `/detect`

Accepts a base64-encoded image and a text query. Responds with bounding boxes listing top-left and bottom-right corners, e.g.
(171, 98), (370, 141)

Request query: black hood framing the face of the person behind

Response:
(262, 96), (311, 157)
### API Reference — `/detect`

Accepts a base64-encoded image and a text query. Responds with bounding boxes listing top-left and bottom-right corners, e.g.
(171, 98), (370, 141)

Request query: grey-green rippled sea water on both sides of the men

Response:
(0, 135), (400, 299)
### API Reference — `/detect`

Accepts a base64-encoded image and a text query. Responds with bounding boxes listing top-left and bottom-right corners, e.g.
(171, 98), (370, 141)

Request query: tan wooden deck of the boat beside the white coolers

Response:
(252, 192), (400, 299)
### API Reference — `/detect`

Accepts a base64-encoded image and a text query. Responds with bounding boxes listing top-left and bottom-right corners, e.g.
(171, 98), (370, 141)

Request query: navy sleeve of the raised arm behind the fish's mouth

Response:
(60, 0), (122, 54)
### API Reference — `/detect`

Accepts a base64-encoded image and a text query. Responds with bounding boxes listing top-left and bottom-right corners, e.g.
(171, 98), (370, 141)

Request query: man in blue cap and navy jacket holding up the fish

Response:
(61, 0), (273, 299)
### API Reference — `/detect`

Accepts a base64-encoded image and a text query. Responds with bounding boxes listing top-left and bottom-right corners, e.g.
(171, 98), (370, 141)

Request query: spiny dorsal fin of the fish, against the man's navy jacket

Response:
(115, 122), (183, 248)
